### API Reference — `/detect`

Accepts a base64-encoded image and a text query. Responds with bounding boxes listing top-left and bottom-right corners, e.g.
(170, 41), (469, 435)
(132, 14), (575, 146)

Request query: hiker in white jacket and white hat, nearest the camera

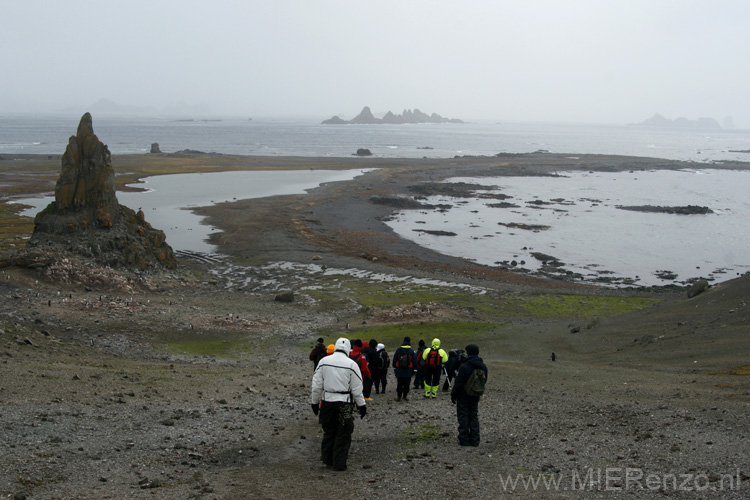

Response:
(310, 337), (367, 471)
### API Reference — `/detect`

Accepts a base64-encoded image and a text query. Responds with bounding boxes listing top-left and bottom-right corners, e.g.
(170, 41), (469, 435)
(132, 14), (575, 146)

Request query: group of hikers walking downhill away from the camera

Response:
(310, 337), (487, 471)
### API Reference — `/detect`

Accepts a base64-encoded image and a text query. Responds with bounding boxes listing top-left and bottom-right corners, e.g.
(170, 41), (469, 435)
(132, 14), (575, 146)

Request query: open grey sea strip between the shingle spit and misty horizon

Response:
(0, 115), (750, 163)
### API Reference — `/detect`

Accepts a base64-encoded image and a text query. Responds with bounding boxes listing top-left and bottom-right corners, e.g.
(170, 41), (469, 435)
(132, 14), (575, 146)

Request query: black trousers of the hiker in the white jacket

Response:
(318, 401), (354, 469)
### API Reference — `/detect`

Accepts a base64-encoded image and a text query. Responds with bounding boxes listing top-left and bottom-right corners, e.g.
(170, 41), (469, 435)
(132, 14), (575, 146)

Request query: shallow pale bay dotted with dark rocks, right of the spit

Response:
(387, 169), (750, 286)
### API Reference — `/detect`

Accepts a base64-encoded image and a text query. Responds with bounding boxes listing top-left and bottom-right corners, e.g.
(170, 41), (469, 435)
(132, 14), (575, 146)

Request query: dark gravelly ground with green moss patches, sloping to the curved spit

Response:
(0, 153), (750, 499)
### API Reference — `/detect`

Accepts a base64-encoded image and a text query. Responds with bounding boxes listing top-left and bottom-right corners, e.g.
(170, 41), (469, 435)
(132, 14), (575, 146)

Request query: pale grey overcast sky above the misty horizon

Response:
(5, 0), (750, 128)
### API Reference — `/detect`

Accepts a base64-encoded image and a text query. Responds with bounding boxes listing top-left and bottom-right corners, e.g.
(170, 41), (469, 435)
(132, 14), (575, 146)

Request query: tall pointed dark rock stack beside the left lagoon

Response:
(20, 113), (176, 269)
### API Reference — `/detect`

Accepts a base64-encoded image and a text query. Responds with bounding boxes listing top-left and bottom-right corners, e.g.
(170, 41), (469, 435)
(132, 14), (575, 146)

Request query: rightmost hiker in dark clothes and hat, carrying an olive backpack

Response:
(451, 344), (487, 446)
